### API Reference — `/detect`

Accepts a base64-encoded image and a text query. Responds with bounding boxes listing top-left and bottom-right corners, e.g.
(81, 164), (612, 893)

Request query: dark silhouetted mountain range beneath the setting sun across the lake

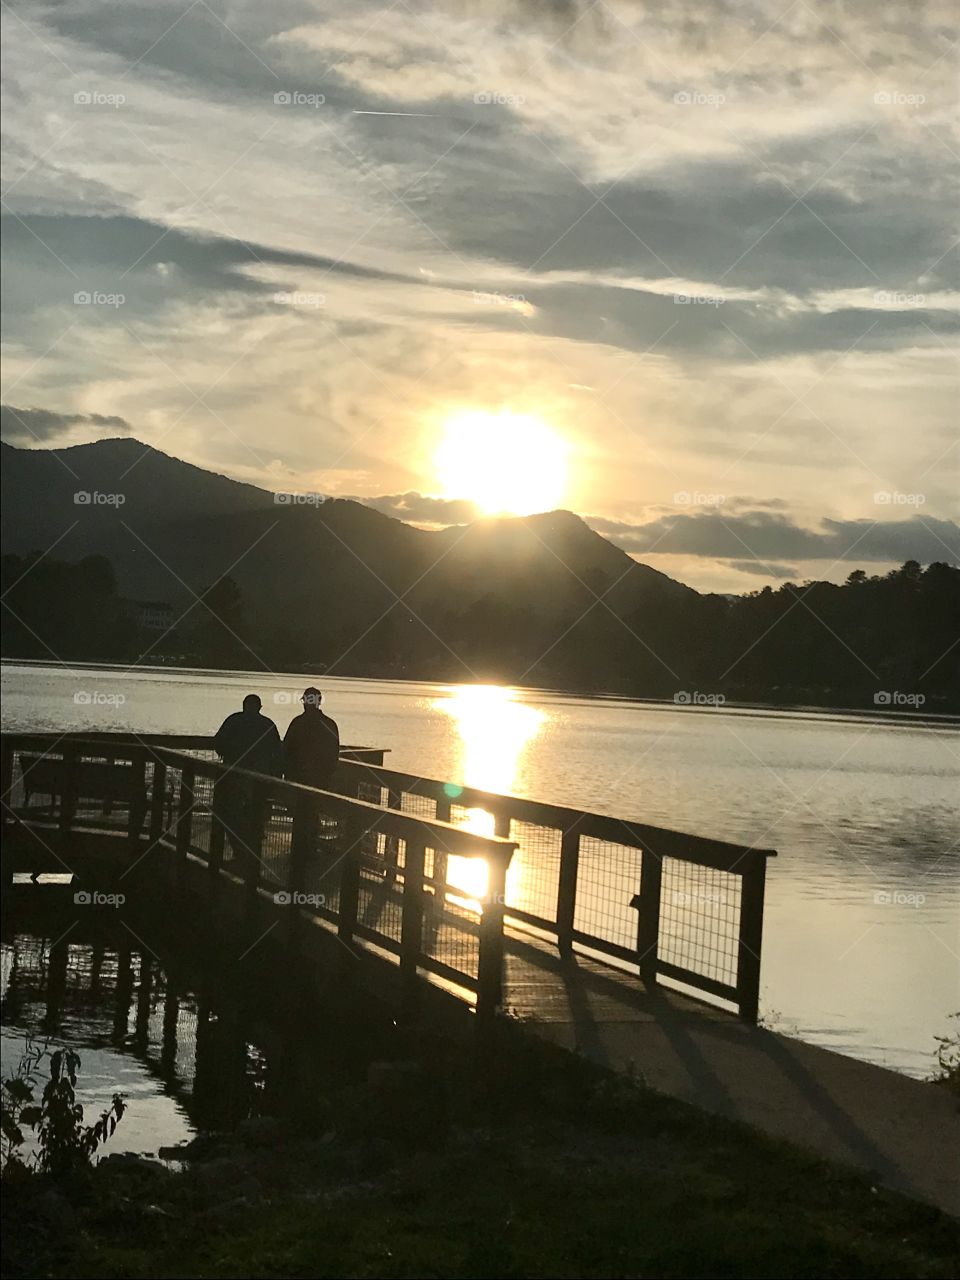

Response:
(3, 438), (699, 690)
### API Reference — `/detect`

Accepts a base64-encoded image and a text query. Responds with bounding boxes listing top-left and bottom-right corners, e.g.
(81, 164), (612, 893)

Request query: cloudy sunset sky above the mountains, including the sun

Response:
(3, 0), (960, 591)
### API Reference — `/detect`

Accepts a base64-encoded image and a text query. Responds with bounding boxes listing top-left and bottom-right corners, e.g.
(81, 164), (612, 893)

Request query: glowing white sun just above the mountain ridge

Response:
(434, 410), (568, 516)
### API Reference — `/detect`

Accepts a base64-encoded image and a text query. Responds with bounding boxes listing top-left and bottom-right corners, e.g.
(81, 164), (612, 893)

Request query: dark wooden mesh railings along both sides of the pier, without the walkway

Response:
(3, 733), (772, 1023)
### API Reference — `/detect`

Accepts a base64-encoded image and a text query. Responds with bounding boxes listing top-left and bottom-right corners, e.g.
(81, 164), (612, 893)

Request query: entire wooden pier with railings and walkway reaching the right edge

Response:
(3, 733), (960, 1213)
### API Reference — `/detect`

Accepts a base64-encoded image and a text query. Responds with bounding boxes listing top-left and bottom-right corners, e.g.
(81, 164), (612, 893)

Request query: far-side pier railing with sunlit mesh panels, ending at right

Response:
(334, 762), (774, 1021)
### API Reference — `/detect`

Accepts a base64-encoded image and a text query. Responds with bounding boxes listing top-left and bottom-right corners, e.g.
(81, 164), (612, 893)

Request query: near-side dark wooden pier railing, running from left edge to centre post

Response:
(3, 735), (516, 1015)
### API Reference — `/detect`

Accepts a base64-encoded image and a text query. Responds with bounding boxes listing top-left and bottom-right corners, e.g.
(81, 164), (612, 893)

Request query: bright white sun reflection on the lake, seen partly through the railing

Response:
(433, 685), (547, 904)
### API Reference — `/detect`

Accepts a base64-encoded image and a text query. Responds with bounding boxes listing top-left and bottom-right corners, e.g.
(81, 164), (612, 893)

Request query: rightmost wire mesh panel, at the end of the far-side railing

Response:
(657, 858), (741, 987)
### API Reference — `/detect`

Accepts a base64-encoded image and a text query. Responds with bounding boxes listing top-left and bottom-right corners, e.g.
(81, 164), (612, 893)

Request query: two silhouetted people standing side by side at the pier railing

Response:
(214, 687), (340, 858)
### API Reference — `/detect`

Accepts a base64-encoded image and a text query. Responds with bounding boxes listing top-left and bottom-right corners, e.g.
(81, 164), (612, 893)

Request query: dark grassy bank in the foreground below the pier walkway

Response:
(4, 1028), (960, 1277)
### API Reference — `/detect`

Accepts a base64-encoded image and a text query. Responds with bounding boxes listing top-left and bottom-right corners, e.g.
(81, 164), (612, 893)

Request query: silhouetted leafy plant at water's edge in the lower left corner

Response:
(1, 1041), (125, 1178)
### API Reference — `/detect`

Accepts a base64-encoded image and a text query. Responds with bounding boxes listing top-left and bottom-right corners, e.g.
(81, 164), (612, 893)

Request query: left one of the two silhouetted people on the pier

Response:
(214, 694), (283, 874)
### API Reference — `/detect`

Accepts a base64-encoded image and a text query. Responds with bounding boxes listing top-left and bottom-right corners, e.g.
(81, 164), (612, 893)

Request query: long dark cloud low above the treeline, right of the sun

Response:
(588, 507), (960, 572)
